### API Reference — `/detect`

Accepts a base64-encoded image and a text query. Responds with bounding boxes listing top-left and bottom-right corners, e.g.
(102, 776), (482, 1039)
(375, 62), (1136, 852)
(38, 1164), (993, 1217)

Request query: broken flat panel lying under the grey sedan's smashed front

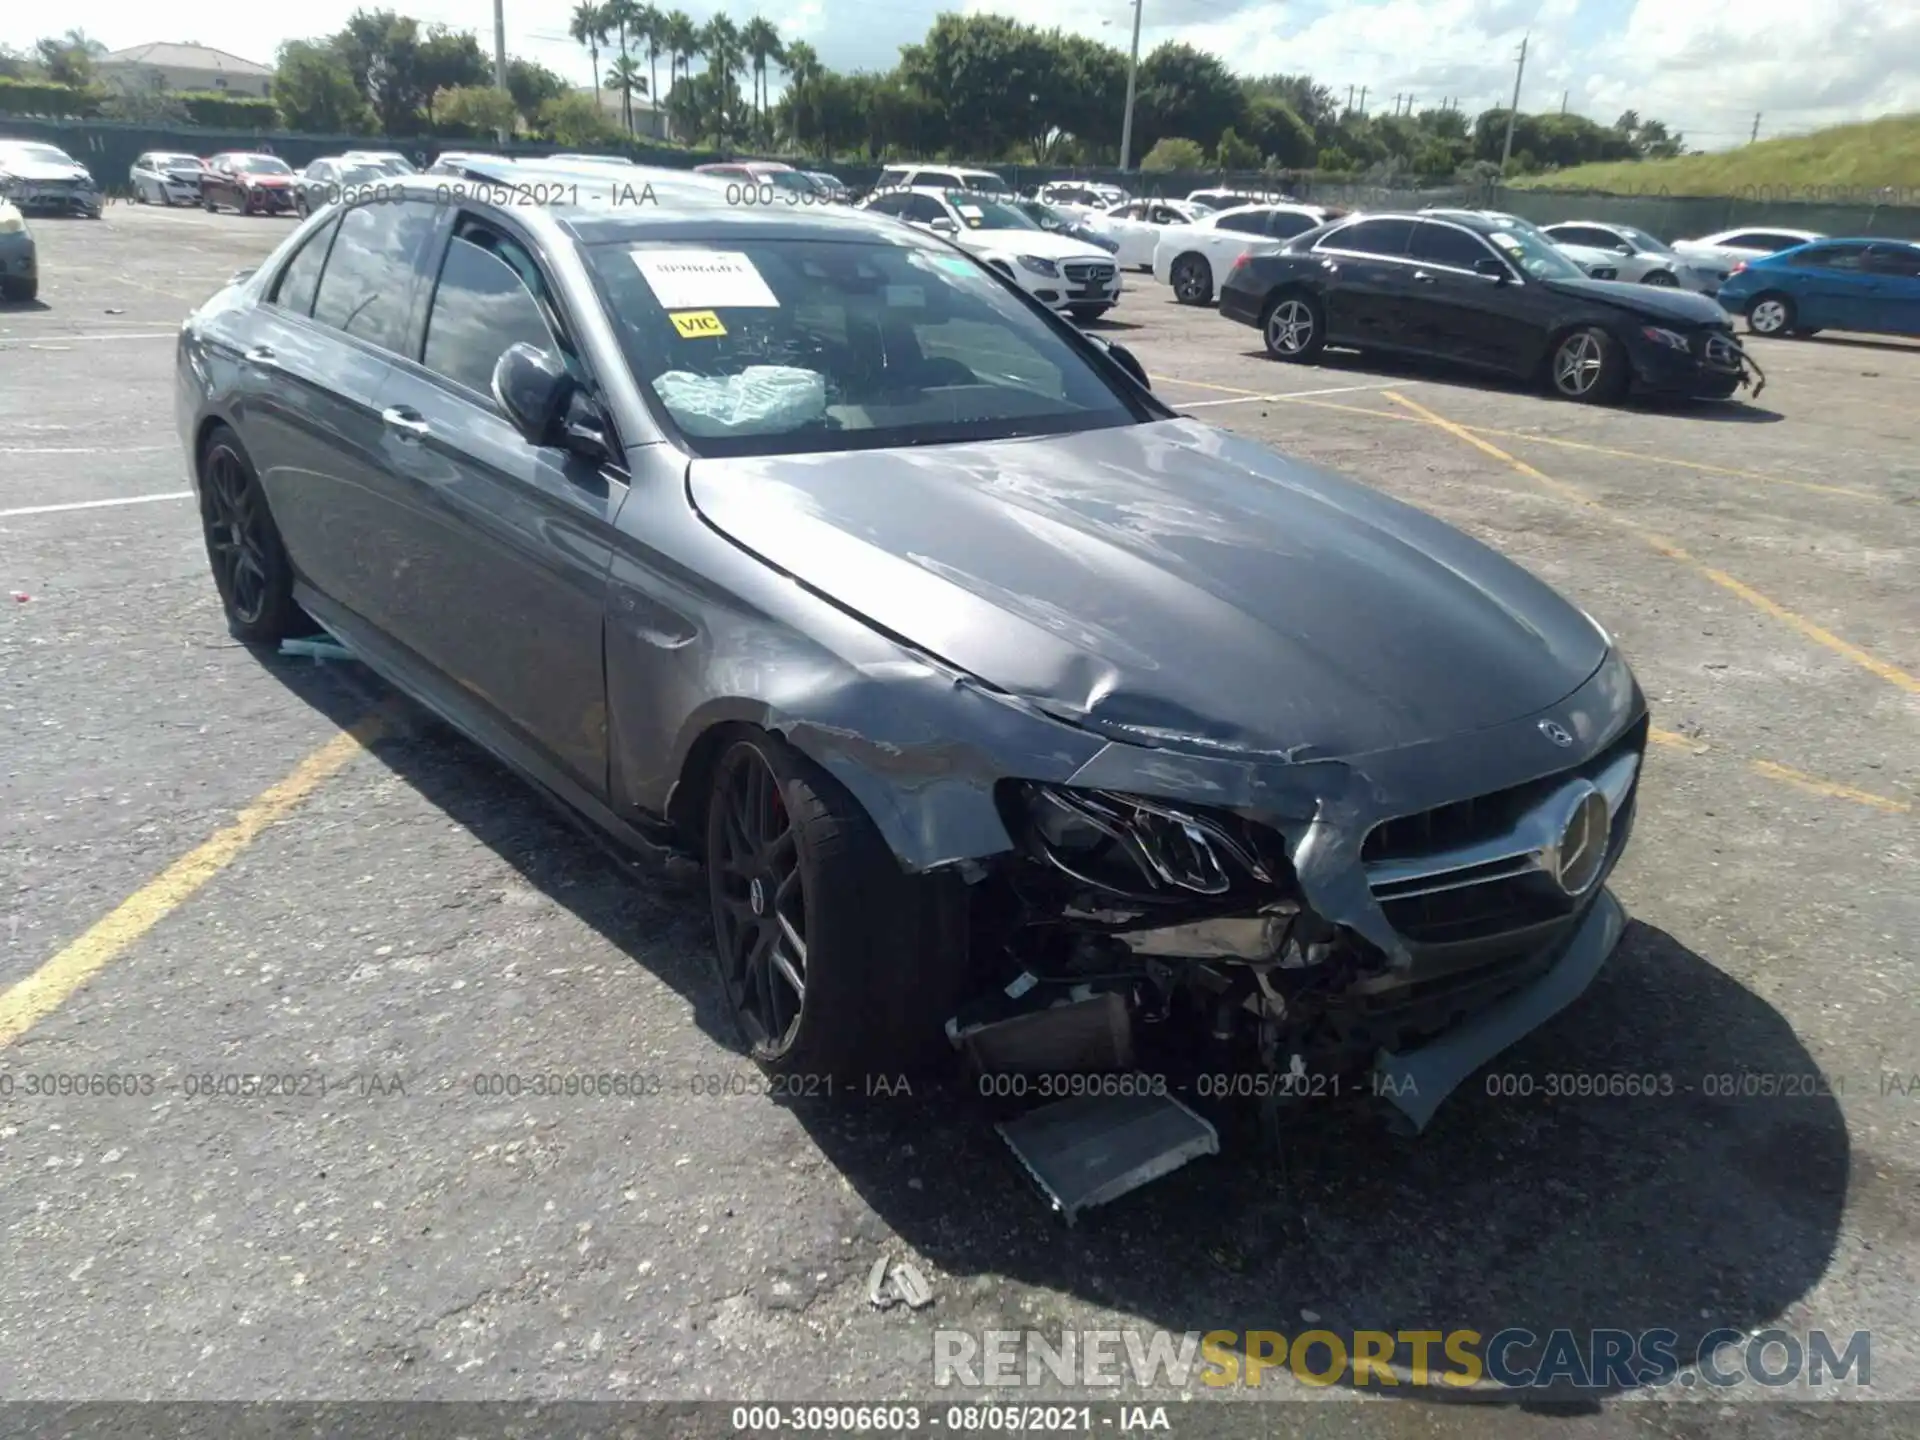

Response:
(998, 1094), (1219, 1225)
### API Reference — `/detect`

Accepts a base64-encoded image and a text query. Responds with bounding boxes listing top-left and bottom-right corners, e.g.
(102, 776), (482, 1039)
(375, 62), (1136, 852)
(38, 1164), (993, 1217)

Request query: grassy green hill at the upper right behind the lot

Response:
(1513, 115), (1920, 205)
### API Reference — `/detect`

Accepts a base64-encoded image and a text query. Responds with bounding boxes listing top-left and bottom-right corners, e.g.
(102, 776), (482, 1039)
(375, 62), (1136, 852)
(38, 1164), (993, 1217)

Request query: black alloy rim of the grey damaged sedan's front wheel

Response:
(707, 741), (808, 1060)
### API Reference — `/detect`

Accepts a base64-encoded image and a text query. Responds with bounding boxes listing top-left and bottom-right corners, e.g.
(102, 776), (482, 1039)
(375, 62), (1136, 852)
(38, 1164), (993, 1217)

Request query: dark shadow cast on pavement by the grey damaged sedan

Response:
(267, 659), (1853, 1405)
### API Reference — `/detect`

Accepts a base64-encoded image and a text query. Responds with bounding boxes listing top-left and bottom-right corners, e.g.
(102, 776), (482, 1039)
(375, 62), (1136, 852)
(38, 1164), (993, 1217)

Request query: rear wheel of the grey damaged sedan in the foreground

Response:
(200, 426), (311, 645)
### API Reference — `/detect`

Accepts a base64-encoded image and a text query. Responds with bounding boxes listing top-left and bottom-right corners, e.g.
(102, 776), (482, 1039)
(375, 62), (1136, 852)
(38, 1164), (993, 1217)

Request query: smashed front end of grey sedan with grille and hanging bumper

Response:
(812, 653), (1647, 1221)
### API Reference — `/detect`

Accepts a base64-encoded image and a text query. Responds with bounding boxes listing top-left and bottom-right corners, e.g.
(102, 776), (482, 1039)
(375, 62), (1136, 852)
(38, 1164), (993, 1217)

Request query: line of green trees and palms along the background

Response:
(0, 12), (1684, 179)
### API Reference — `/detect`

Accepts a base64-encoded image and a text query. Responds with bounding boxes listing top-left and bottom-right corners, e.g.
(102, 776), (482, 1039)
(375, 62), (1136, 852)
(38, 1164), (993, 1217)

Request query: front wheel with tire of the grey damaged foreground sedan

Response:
(707, 726), (966, 1079)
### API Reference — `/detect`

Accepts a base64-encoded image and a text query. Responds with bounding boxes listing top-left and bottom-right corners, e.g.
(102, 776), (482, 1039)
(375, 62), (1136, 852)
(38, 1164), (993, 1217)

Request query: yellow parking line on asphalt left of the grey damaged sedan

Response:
(0, 716), (386, 1046)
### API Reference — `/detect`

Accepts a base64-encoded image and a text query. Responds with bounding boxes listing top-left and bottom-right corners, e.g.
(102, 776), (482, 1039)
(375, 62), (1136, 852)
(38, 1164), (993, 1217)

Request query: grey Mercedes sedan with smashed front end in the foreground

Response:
(177, 161), (1647, 1123)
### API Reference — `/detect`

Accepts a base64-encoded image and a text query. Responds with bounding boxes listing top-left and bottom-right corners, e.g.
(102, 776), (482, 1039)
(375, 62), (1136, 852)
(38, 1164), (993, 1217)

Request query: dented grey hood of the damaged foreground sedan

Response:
(687, 419), (1605, 758)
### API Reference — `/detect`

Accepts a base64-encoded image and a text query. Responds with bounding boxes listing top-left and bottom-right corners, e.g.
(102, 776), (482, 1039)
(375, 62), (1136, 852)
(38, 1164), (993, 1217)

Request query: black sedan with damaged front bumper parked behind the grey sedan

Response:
(1219, 211), (1766, 403)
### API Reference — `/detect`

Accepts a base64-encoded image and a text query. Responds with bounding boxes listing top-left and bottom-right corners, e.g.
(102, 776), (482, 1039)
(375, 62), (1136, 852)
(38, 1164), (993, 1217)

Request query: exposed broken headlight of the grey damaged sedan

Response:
(1012, 785), (1273, 899)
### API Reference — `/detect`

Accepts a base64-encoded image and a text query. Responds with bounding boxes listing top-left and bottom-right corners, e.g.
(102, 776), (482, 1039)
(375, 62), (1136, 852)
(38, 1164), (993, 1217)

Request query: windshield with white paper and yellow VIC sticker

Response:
(588, 238), (1148, 457)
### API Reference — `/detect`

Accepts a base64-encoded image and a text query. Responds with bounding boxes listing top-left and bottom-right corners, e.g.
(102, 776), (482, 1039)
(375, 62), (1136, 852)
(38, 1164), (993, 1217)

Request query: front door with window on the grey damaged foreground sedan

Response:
(366, 211), (628, 797)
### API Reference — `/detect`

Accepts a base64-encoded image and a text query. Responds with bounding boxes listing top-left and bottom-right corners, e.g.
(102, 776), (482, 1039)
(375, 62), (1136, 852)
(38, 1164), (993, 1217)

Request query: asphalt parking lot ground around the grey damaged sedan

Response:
(0, 205), (1920, 1434)
